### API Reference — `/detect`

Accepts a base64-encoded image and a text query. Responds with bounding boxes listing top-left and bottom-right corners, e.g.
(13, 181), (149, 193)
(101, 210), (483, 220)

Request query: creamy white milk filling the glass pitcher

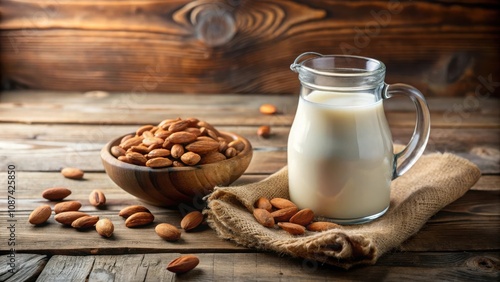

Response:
(288, 91), (393, 220)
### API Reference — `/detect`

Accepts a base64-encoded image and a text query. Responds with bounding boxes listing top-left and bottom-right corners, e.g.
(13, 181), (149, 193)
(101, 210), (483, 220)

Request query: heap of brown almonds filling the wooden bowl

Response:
(111, 118), (245, 168)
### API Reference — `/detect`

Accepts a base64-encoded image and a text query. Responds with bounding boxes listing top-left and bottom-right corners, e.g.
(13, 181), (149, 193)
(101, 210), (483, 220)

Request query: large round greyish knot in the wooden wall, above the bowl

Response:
(191, 5), (236, 47)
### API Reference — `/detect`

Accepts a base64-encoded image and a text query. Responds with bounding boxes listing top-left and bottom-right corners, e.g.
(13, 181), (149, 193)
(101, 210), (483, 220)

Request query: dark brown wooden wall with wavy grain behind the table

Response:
(0, 0), (500, 97)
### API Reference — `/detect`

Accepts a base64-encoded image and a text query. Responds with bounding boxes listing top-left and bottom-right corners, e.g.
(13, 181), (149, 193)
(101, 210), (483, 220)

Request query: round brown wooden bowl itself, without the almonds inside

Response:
(101, 132), (253, 208)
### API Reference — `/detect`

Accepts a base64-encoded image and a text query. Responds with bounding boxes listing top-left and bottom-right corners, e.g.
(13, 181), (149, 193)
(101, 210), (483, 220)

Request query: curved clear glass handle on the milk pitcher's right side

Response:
(382, 83), (431, 179)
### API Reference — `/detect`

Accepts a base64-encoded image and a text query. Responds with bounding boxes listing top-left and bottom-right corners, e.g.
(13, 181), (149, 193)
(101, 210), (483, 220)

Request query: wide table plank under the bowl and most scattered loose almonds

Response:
(0, 172), (500, 255)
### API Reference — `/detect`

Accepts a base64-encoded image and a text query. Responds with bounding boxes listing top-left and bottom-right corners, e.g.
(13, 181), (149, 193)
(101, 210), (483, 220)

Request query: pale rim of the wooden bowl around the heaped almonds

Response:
(101, 131), (253, 173)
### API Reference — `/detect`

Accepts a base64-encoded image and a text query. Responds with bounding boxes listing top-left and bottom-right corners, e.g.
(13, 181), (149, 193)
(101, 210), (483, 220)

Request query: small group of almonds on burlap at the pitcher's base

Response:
(253, 197), (340, 235)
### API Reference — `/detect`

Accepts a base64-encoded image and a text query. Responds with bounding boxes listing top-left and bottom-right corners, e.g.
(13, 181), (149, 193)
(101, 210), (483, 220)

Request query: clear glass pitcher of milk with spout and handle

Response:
(287, 52), (430, 224)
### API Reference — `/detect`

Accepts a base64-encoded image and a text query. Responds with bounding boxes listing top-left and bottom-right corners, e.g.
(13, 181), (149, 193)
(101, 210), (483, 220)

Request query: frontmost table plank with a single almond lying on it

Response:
(37, 252), (500, 282)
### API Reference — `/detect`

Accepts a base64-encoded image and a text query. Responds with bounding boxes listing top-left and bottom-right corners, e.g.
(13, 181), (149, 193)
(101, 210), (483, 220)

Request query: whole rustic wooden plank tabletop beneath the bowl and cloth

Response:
(0, 91), (500, 281)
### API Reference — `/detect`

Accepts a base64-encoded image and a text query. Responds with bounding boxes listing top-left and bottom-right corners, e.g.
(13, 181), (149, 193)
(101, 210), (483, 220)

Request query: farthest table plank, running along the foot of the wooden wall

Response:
(0, 94), (500, 129)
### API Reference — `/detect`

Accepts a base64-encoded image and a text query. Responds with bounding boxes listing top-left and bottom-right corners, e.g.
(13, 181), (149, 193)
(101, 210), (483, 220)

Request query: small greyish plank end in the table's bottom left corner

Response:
(0, 253), (49, 282)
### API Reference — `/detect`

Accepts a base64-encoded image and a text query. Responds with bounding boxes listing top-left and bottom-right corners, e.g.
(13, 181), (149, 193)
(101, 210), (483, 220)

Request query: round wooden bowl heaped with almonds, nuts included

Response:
(101, 118), (252, 207)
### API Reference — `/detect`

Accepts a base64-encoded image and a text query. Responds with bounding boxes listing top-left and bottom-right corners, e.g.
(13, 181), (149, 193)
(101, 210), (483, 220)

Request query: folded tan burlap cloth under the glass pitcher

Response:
(204, 153), (481, 269)
